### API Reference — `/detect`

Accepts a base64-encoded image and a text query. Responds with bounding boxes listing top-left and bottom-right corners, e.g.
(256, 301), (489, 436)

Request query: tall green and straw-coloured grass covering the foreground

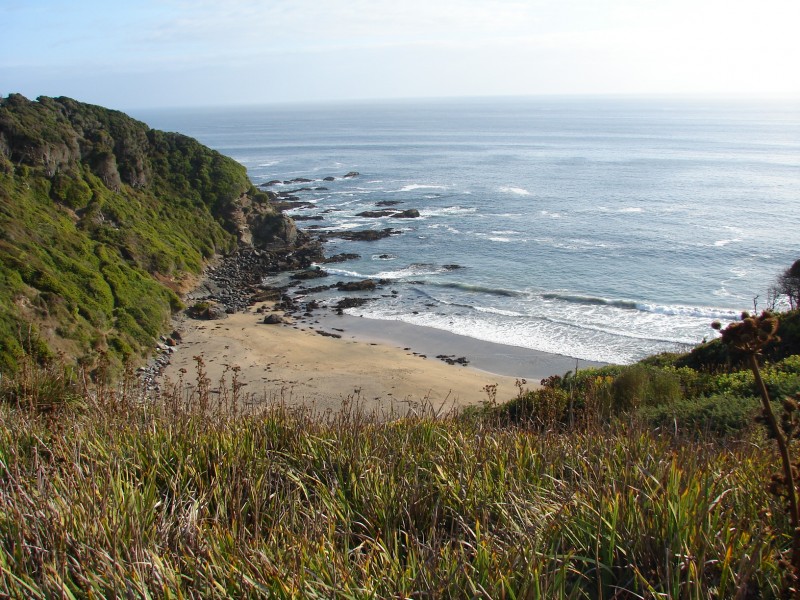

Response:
(0, 361), (791, 598)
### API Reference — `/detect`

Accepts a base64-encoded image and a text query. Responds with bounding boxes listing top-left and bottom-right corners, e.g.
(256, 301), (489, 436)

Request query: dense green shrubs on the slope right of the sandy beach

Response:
(478, 310), (800, 435)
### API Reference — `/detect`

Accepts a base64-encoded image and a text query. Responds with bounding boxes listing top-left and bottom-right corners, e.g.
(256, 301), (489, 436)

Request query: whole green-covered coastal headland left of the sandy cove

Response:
(0, 94), (314, 372)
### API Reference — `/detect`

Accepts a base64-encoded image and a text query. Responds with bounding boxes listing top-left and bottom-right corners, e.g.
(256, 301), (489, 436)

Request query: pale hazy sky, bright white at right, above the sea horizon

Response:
(0, 0), (800, 110)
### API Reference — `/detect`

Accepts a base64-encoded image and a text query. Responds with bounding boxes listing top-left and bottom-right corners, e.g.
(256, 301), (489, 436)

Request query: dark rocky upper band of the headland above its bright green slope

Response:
(0, 94), (307, 249)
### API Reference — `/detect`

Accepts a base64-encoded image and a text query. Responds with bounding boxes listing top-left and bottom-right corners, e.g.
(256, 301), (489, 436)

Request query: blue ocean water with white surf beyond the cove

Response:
(138, 98), (800, 363)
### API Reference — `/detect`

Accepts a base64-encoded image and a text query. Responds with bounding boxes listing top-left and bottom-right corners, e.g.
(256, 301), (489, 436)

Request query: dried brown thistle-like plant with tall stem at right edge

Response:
(711, 311), (800, 598)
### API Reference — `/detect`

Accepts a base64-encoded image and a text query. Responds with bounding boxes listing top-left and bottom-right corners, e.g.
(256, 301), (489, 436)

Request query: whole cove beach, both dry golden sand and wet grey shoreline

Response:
(156, 306), (596, 415)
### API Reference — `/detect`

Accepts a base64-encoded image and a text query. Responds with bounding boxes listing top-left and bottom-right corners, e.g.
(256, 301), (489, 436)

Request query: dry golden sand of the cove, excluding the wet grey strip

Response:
(164, 312), (530, 414)
